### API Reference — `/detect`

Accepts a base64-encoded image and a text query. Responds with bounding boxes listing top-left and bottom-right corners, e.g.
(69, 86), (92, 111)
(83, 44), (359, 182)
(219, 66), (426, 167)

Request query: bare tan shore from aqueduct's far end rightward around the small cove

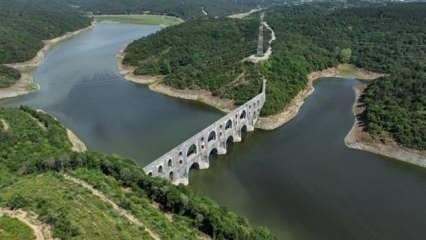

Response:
(256, 64), (383, 130)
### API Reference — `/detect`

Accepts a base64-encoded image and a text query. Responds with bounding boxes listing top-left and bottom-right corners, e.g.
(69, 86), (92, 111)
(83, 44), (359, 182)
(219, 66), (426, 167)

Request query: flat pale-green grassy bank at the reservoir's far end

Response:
(94, 14), (183, 26)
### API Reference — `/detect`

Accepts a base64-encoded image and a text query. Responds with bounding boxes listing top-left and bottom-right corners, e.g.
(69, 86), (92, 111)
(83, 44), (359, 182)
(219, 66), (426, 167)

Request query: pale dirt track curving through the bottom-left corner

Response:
(0, 208), (53, 240)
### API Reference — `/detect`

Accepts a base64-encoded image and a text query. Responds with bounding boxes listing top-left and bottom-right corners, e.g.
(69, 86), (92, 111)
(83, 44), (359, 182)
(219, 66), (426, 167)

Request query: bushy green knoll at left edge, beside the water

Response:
(0, 107), (71, 173)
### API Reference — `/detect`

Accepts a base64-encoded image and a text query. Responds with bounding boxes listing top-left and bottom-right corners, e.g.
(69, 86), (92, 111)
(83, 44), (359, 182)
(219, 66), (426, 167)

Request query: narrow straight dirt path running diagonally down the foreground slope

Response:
(64, 174), (161, 240)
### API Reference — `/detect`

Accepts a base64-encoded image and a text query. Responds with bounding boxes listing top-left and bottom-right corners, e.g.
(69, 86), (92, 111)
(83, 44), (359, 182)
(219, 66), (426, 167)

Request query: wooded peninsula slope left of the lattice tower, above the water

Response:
(123, 19), (258, 94)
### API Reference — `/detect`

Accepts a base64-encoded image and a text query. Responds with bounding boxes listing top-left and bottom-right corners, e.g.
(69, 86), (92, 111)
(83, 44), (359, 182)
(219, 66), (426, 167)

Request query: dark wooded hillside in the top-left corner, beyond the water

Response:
(0, 0), (91, 88)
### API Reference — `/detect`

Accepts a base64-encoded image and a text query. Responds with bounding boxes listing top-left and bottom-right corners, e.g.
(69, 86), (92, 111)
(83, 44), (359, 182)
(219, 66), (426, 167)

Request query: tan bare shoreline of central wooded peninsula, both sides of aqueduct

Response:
(117, 46), (385, 130)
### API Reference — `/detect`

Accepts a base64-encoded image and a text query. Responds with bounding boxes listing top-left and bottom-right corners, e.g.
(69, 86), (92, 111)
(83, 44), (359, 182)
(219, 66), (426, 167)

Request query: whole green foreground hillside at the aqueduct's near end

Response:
(0, 107), (274, 240)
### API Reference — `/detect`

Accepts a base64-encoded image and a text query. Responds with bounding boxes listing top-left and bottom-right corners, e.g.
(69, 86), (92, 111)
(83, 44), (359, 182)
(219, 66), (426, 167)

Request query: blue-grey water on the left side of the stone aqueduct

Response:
(0, 23), (222, 165)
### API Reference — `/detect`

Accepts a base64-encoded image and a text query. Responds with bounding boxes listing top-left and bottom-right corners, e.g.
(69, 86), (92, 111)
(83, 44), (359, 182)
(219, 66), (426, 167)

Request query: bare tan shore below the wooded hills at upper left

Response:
(0, 20), (96, 99)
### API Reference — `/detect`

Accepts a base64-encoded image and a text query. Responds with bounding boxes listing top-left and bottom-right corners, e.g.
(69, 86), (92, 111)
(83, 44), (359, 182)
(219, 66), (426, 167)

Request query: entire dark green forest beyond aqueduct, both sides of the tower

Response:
(125, 2), (426, 149)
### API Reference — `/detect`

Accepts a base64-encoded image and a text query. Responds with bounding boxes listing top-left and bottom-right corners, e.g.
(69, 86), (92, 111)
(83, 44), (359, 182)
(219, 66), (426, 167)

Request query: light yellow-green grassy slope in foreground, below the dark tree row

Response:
(0, 174), (154, 239)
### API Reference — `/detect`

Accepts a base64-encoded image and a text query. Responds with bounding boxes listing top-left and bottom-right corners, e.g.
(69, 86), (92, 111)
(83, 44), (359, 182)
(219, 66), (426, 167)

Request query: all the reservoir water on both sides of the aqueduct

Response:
(0, 23), (426, 240)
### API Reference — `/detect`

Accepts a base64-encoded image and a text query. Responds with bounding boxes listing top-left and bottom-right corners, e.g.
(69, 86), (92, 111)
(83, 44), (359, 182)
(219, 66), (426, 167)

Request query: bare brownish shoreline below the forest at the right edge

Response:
(344, 84), (426, 167)
